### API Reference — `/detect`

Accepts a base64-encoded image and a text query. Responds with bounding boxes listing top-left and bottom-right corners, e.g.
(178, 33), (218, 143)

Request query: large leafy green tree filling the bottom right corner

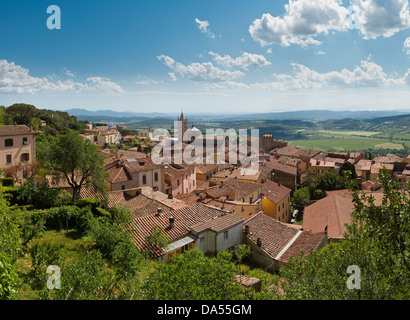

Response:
(278, 169), (410, 300)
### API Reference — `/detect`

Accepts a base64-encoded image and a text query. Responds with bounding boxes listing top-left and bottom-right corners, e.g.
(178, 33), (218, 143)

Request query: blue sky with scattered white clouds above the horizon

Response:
(0, 0), (410, 113)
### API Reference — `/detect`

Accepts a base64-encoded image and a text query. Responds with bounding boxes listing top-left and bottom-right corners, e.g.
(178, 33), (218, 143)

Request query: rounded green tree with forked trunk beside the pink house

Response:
(39, 130), (107, 205)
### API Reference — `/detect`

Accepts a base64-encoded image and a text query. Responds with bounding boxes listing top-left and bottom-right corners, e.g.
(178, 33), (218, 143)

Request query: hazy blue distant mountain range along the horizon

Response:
(65, 109), (410, 121)
